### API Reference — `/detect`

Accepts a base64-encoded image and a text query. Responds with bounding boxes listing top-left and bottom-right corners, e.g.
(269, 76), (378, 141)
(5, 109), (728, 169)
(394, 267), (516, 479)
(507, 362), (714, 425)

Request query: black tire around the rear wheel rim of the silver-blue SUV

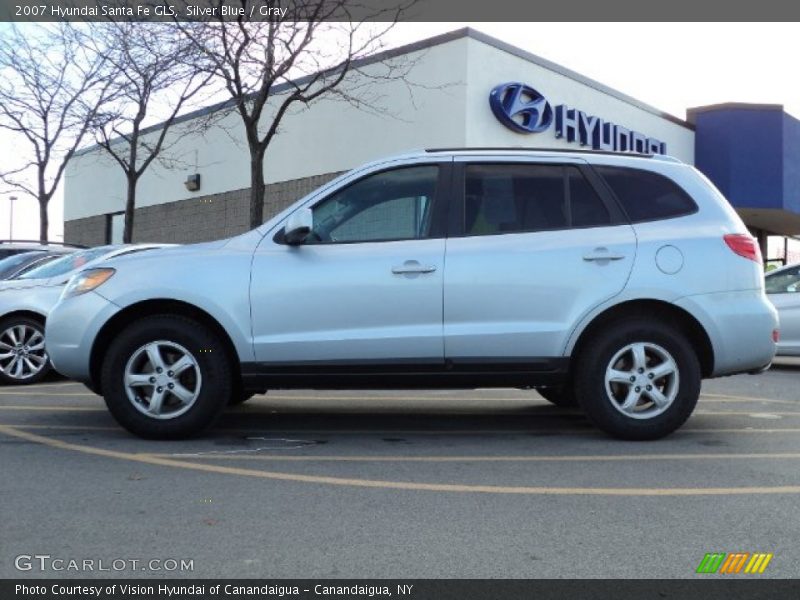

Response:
(574, 317), (702, 440)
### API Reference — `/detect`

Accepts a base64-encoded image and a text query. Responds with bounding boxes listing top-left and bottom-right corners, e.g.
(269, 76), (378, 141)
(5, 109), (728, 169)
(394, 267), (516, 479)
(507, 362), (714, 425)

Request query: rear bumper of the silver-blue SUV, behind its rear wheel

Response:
(675, 290), (778, 377)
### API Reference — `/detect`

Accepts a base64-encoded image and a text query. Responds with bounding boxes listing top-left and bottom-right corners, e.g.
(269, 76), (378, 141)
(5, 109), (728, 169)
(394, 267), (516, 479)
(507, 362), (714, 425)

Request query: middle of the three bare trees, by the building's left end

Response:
(87, 21), (212, 243)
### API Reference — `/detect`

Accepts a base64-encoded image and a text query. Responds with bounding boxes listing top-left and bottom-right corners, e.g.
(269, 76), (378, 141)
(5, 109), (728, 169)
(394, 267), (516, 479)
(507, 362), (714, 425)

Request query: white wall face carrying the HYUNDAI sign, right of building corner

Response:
(466, 39), (694, 164)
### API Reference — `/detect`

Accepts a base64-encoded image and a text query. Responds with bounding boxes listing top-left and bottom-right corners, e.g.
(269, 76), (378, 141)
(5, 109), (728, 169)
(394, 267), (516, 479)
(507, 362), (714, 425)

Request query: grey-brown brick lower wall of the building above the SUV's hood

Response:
(64, 173), (339, 246)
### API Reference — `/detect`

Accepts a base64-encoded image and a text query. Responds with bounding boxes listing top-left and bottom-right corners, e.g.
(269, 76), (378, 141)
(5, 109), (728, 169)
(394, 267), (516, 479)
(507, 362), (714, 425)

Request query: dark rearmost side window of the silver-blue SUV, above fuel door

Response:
(595, 166), (697, 223)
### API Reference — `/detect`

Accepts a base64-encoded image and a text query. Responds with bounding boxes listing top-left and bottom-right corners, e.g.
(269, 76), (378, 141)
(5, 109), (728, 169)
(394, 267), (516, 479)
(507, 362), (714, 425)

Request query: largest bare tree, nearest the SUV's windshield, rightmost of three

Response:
(180, 0), (413, 227)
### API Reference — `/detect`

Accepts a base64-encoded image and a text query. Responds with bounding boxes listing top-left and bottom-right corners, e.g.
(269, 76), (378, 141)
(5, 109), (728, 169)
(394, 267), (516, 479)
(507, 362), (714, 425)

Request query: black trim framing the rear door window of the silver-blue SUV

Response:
(448, 159), (629, 238)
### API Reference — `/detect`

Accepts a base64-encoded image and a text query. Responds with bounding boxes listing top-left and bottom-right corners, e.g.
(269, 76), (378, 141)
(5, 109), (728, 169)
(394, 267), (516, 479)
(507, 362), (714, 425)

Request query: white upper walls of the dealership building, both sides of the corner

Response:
(64, 31), (694, 221)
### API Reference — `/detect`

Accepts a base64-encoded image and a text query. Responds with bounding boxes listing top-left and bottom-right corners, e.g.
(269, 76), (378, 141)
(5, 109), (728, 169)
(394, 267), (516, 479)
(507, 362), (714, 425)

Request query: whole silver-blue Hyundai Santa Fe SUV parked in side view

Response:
(46, 150), (778, 440)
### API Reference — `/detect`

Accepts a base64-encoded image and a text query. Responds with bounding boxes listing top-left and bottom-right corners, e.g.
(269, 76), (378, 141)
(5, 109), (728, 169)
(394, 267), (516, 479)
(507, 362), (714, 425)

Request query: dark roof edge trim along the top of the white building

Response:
(73, 27), (692, 156)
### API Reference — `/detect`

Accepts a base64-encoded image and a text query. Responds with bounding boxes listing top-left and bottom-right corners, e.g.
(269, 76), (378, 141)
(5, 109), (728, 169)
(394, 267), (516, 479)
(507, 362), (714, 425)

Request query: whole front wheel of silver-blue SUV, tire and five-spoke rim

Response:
(102, 315), (231, 439)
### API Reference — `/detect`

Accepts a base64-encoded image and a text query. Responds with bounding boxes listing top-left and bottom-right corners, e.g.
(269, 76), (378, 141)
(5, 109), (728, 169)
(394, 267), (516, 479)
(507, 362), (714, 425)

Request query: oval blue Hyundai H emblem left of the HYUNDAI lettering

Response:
(489, 83), (553, 133)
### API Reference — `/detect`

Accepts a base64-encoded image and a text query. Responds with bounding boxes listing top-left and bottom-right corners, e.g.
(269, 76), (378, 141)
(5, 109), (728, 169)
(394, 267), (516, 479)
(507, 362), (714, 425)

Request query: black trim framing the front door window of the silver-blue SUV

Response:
(272, 160), (453, 246)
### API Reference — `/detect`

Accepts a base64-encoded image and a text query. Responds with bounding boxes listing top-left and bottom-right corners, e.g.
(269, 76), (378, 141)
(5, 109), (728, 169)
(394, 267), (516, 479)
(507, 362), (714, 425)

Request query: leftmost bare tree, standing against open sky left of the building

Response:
(0, 23), (110, 241)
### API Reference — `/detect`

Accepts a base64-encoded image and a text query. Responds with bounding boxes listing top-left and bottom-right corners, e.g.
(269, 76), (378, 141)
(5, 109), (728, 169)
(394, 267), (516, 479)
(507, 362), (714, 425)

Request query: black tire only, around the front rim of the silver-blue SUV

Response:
(101, 315), (232, 439)
